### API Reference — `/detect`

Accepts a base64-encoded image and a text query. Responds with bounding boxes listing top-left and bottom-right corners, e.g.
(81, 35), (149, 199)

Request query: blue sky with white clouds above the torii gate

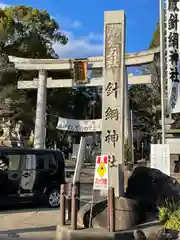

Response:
(0, 0), (159, 58)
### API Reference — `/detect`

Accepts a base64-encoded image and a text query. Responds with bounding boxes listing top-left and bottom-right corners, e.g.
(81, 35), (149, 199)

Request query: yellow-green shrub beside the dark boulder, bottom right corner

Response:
(158, 202), (180, 231)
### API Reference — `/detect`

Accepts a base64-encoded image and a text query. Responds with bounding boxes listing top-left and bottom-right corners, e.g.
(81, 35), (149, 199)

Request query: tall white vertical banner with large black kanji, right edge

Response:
(165, 0), (180, 113)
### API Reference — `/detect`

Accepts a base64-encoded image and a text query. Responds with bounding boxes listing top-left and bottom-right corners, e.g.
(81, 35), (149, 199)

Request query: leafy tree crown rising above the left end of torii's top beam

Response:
(0, 6), (68, 58)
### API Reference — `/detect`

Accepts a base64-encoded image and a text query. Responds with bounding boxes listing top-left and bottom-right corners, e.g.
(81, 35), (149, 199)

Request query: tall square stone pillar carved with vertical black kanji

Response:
(101, 11), (125, 197)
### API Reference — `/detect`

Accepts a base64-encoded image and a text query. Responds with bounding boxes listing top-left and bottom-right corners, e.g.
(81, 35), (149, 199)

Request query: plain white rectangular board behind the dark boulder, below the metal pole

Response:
(151, 144), (170, 176)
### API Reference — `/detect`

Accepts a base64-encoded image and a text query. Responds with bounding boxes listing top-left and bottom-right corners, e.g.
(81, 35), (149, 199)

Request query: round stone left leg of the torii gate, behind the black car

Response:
(34, 70), (47, 148)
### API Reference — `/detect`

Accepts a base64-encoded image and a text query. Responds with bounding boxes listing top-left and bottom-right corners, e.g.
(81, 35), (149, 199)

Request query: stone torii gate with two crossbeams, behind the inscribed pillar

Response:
(9, 43), (159, 148)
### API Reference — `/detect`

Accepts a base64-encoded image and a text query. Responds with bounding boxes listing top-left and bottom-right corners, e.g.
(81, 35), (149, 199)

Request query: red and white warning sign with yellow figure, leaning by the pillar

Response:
(93, 155), (109, 190)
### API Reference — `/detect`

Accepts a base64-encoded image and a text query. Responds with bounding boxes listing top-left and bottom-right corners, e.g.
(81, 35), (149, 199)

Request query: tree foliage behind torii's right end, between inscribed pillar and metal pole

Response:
(129, 25), (160, 135)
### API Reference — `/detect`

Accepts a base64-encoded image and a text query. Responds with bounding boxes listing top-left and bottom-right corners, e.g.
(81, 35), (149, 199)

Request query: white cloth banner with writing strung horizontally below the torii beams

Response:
(56, 117), (102, 132)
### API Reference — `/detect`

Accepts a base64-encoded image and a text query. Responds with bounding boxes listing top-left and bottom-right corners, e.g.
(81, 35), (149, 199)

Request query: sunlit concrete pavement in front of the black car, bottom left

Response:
(0, 208), (59, 239)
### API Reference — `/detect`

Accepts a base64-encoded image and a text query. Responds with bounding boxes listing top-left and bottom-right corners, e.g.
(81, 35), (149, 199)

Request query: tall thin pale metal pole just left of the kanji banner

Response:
(159, 0), (166, 144)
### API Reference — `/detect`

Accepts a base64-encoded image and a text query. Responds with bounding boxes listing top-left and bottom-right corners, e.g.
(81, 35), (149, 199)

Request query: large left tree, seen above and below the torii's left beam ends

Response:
(0, 6), (68, 135)
